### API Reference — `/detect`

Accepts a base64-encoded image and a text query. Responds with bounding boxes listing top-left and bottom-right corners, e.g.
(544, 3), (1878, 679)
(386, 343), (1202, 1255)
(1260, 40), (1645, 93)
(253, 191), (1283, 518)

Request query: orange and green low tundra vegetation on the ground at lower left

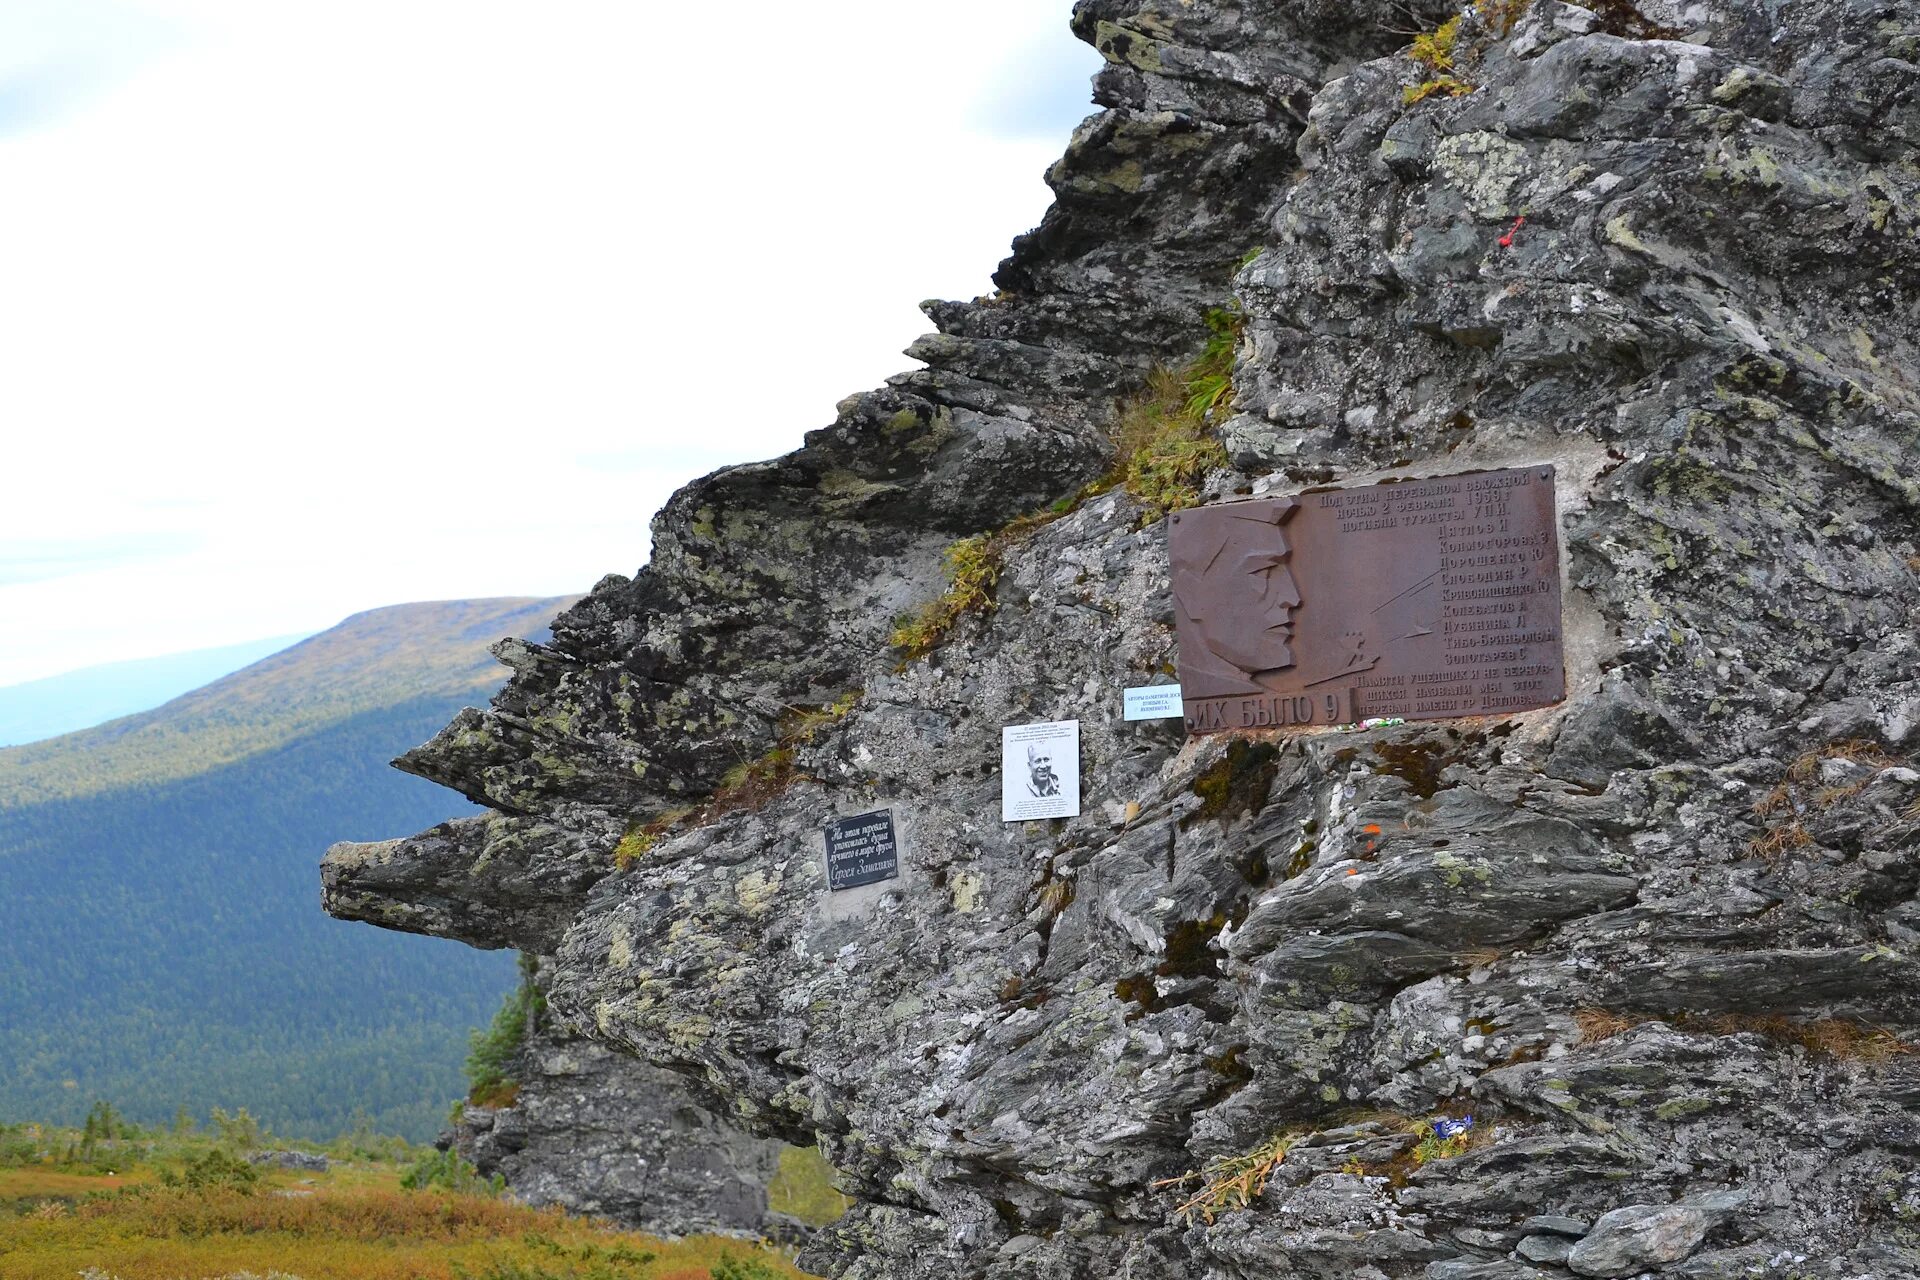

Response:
(0, 1117), (817, 1280)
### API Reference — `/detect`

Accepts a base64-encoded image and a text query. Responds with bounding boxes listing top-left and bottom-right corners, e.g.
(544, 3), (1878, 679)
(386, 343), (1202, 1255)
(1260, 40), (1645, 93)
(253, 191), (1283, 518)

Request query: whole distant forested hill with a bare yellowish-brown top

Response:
(0, 601), (566, 1138)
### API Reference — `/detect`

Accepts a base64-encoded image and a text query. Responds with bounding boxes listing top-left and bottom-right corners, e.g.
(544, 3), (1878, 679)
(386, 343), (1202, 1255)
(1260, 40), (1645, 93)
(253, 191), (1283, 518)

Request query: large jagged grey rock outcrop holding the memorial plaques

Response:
(328, 0), (1920, 1280)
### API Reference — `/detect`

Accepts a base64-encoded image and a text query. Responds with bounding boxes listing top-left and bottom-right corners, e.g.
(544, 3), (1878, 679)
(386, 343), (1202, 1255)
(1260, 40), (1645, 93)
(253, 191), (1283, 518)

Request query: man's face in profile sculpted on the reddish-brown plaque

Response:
(1173, 497), (1300, 683)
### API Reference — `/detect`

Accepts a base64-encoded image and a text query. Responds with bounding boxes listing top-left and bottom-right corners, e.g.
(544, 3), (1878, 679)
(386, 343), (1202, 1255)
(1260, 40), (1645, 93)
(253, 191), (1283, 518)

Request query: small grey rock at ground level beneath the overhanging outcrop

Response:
(453, 990), (781, 1236)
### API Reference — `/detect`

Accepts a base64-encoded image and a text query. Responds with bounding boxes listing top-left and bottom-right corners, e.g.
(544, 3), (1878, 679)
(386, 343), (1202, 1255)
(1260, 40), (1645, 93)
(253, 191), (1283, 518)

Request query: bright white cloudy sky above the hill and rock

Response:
(0, 0), (1098, 685)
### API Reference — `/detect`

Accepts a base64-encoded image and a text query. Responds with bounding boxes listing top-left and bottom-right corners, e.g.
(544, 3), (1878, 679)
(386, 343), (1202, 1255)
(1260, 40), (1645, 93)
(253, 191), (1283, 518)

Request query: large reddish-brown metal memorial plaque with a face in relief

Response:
(1167, 466), (1567, 733)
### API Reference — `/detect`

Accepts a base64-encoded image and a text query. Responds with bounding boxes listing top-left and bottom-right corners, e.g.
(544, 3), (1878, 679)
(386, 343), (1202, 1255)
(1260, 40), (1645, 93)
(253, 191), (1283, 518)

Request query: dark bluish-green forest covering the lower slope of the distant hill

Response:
(0, 693), (515, 1140)
